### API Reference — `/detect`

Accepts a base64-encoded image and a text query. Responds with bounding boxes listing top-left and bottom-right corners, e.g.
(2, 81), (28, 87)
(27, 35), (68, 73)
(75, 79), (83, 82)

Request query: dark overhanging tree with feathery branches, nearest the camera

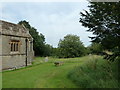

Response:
(79, 2), (120, 61)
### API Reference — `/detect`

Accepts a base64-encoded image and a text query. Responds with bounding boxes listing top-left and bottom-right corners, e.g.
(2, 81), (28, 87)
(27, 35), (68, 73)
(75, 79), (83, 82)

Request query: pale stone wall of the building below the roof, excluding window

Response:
(2, 35), (33, 69)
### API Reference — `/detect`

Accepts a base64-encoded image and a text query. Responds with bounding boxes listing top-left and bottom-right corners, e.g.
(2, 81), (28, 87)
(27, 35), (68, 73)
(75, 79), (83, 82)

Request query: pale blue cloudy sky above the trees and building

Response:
(0, 2), (92, 47)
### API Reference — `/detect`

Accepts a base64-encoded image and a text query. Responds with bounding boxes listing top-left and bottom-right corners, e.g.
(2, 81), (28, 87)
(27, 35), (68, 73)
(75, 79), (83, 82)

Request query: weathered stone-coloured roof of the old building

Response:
(0, 20), (31, 37)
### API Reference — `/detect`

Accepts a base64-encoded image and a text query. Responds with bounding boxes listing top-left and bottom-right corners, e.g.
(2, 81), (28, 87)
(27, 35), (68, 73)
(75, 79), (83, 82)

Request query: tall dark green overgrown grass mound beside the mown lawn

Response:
(68, 58), (119, 88)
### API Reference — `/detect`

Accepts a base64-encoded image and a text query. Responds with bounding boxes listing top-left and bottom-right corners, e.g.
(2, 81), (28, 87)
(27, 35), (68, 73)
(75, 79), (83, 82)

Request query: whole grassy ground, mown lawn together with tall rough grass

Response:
(2, 55), (118, 88)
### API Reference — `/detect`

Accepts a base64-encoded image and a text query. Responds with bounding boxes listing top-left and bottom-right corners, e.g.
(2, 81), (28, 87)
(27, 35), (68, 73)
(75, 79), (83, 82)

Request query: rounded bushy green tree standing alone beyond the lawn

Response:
(58, 34), (85, 58)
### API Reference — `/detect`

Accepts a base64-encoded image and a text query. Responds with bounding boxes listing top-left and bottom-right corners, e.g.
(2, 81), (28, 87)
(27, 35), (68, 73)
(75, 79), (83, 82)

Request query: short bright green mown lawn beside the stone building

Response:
(3, 55), (118, 88)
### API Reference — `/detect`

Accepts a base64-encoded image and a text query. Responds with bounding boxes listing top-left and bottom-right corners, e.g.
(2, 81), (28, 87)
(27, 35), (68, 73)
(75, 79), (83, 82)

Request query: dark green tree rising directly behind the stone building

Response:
(18, 20), (45, 56)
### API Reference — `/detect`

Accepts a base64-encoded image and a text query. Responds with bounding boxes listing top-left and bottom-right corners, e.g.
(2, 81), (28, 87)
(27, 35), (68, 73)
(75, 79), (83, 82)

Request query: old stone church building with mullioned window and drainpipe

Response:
(0, 20), (34, 70)
